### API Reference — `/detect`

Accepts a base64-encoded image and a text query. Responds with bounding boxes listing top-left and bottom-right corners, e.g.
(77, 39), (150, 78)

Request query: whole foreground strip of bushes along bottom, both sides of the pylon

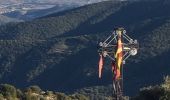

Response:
(0, 76), (170, 100)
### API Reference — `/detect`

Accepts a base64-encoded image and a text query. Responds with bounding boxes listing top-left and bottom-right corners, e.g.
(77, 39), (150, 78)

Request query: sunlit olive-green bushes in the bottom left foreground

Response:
(0, 84), (89, 100)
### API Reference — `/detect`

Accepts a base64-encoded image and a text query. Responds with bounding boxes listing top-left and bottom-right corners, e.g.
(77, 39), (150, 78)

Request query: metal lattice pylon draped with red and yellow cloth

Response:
(98, 28), (139, 100)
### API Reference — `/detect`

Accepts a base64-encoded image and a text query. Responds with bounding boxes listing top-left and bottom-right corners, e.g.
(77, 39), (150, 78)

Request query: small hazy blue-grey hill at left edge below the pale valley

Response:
(0, 15), (22, 25)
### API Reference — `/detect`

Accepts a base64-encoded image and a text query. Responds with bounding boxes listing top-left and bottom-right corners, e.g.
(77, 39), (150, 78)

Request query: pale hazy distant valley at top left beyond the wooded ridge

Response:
(0, 0), (112, 21)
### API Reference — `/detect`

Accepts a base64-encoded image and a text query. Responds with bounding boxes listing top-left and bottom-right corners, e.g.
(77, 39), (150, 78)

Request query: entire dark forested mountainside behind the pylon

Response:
(0, 0), (170, 95)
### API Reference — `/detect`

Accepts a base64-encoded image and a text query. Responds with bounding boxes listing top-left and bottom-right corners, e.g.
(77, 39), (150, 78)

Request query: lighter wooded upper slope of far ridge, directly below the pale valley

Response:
(0, 1), (124, 39)
